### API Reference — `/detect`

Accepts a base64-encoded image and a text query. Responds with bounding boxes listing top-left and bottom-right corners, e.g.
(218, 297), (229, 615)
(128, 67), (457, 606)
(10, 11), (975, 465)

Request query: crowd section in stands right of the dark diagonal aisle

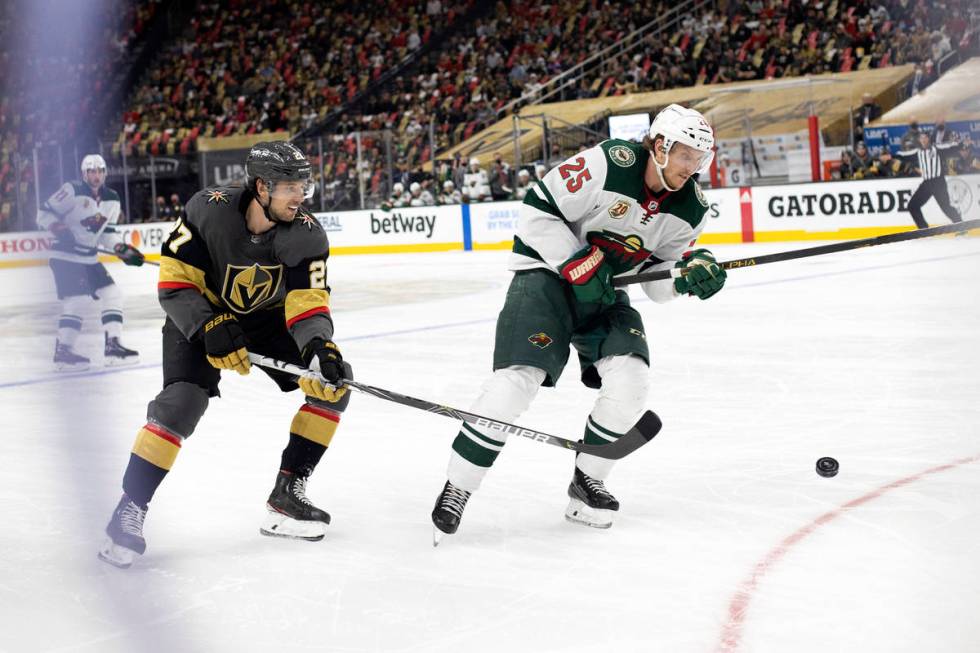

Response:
(343, 0), (978, 196)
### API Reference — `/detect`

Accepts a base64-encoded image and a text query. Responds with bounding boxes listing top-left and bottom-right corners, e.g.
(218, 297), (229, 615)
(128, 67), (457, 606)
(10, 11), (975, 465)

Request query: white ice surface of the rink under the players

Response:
(0, 238), (980, 653)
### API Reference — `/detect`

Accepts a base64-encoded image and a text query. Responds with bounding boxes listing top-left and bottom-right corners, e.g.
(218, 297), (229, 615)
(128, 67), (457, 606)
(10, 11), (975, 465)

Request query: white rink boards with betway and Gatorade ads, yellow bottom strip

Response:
(0, 175), (980, 267)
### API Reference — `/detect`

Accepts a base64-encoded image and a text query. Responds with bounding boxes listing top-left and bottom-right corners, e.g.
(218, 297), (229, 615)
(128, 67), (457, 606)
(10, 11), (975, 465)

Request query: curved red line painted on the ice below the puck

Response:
(718, 454), (980, 653)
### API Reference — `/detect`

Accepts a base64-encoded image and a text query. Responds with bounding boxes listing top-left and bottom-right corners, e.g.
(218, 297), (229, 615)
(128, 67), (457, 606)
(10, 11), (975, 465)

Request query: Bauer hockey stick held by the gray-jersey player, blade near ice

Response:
(248, 353), (663, 460)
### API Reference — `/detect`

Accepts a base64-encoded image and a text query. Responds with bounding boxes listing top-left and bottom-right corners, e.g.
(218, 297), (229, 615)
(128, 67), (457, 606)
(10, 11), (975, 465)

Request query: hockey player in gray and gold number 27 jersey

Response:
(99, 141), (353, 567)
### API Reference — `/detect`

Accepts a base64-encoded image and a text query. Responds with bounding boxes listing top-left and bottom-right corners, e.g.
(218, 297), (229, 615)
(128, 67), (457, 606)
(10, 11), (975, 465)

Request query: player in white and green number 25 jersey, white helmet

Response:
(432, 104), (726, 543)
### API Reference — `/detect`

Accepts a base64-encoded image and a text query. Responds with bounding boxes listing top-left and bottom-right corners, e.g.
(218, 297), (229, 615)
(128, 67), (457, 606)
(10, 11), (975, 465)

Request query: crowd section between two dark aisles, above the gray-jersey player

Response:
(116, 0), (474, 154)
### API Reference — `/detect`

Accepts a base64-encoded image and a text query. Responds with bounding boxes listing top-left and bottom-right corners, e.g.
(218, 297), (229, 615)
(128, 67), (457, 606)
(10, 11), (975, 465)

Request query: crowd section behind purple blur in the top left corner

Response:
(0, 0), (159, 231)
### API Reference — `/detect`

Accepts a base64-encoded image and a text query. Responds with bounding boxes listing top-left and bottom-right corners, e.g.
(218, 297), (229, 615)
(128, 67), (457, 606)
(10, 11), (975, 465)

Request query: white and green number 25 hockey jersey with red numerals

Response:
(509, 139), (708, 302)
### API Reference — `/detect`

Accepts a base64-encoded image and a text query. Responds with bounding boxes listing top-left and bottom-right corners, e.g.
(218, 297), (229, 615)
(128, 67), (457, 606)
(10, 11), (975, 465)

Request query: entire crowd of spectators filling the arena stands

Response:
(0, 0), (980, 227)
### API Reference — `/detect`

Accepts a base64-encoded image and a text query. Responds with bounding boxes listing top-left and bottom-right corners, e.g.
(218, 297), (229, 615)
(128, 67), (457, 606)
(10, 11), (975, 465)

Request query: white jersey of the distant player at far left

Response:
(37, 181), (122, 263)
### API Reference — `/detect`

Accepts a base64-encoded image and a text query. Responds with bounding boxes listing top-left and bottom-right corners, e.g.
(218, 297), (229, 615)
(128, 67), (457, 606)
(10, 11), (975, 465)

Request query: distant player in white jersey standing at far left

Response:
(37, 154), (144, 371)
